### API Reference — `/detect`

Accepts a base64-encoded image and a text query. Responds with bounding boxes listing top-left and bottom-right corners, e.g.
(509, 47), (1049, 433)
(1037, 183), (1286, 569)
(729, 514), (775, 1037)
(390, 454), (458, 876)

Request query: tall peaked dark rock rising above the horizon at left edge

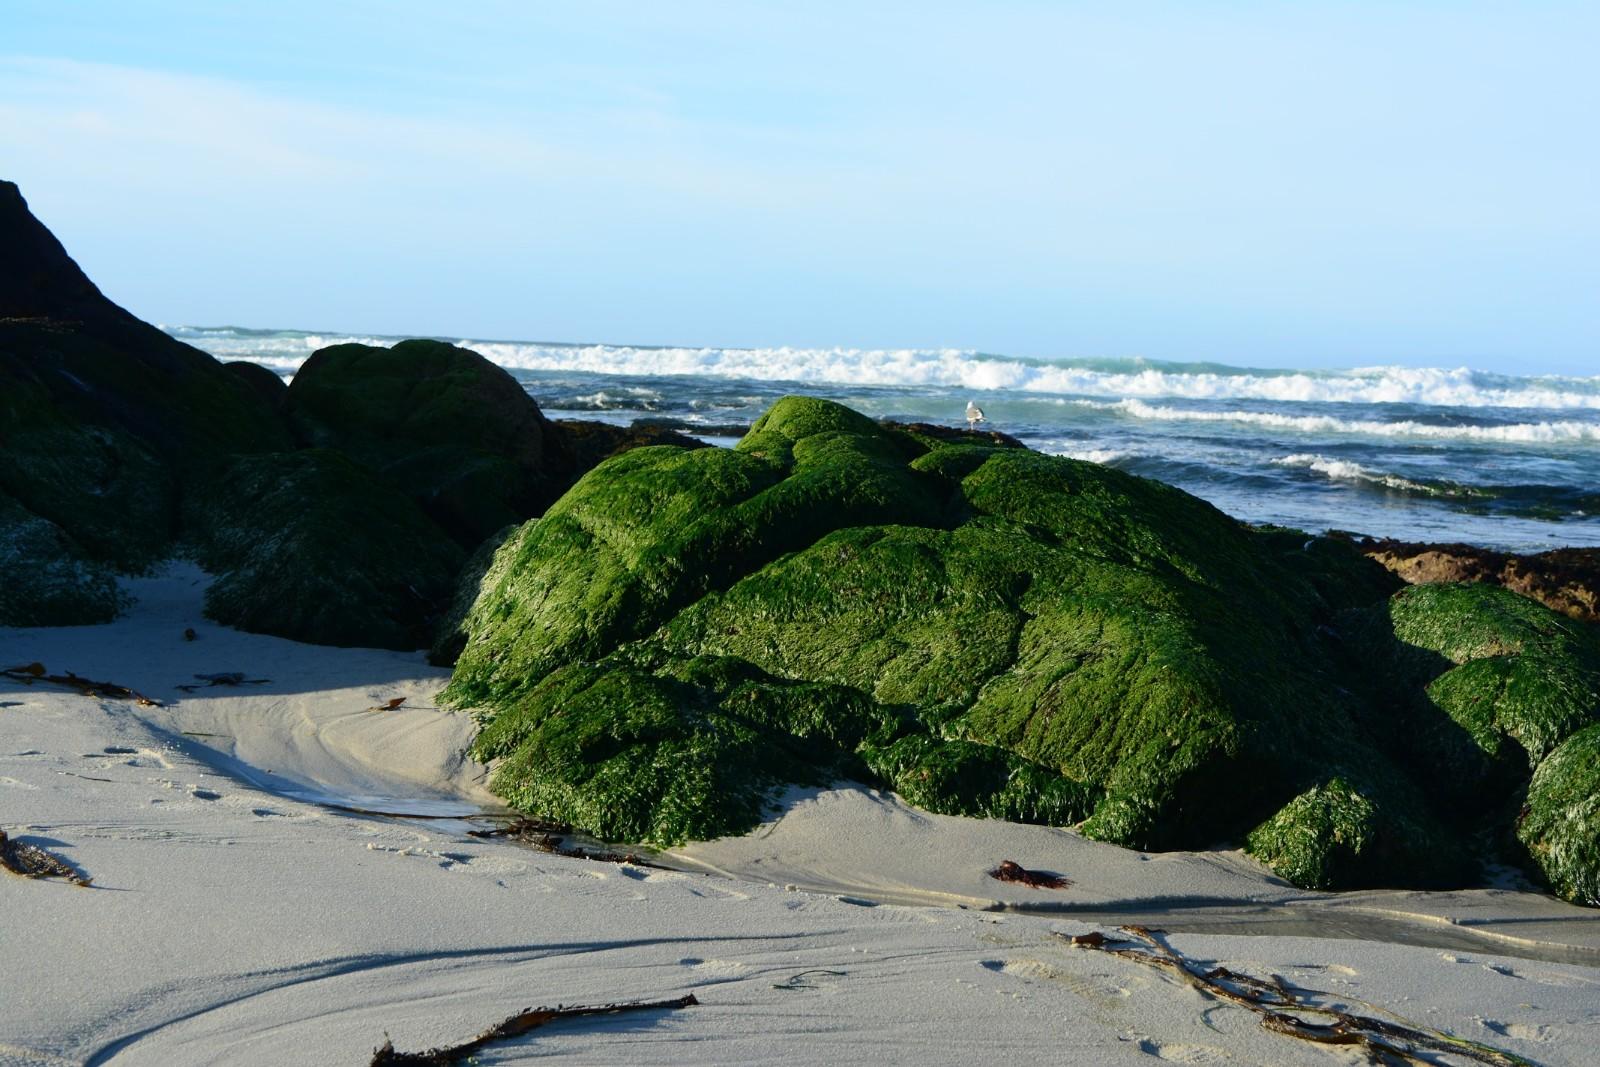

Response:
(0, 182), (288, 585)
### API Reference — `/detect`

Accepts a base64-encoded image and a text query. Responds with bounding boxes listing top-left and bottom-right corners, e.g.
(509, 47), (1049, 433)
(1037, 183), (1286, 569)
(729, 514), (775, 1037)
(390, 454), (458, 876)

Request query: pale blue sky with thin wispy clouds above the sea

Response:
(0, 0), (1600, 374)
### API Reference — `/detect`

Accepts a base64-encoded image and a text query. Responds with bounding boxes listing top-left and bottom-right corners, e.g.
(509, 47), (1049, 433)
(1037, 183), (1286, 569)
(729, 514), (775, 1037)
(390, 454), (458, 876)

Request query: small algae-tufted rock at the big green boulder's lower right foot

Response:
(1246, 777), (1469, 889)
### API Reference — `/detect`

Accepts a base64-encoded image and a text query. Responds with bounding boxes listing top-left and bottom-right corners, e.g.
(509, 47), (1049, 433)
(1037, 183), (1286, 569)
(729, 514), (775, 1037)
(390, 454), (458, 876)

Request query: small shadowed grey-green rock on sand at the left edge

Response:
(0, 493), (123, 625)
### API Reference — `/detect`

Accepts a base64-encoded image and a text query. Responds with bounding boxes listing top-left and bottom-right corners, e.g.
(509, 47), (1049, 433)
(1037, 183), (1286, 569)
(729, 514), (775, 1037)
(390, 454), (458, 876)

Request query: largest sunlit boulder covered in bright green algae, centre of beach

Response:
(443, 397), (1516, 885)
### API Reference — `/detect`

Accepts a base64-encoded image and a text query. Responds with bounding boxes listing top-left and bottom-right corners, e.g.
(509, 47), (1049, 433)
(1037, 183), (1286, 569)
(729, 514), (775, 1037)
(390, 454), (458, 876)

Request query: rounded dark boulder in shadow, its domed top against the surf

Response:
(285, 339), (571, 549)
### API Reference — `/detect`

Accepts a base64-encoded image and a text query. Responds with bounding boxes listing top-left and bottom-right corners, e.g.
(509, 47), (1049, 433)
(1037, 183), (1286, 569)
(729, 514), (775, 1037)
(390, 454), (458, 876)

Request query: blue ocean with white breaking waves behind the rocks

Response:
(163, 326), (1600, 552)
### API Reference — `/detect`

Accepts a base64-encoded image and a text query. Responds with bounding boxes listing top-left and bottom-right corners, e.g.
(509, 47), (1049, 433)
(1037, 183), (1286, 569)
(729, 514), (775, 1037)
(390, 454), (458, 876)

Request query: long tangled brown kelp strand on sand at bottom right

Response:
(1067, 926), (1536, 1067)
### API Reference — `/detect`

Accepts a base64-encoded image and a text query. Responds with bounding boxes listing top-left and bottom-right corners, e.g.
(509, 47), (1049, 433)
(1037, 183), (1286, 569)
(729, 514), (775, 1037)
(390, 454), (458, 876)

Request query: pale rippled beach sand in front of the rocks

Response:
(0, 566), (1600, 1065)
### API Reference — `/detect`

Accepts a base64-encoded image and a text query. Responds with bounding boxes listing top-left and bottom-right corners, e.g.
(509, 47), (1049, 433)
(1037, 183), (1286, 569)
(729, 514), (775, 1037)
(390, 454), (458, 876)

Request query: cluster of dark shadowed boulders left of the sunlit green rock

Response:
(0, 182), (732, 648)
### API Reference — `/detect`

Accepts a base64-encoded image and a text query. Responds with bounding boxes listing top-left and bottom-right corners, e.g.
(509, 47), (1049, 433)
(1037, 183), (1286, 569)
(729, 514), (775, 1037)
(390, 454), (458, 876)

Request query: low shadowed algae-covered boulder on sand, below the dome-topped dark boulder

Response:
(187, 450), (464, 649)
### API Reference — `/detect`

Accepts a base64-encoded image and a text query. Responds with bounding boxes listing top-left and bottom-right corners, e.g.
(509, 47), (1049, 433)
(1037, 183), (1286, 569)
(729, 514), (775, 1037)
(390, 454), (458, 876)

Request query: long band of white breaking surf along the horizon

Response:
(168, 326), (1600, 411)
